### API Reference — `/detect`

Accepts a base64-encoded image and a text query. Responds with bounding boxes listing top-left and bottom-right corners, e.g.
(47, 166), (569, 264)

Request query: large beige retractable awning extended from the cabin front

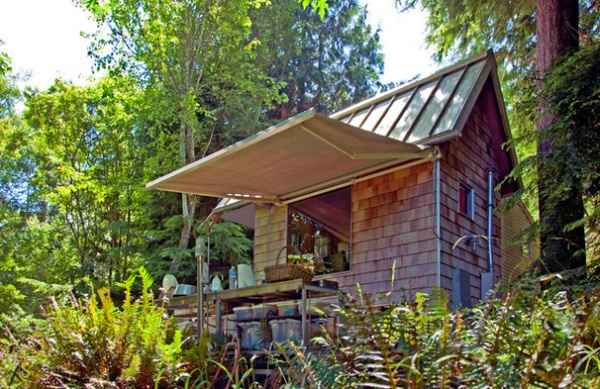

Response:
(146, 110), (428, 203)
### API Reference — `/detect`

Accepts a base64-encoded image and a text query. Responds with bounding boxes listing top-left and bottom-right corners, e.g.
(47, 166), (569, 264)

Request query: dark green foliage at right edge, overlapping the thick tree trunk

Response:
(542, 46), (600, 263)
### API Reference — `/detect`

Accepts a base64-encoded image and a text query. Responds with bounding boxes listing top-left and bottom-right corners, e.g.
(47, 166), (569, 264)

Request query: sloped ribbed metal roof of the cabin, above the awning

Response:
(331, 52), (507, 145)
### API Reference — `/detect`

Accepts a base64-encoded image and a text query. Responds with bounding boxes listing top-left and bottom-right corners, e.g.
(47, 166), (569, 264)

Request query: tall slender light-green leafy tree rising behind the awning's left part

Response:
(80, 0), (284, 270)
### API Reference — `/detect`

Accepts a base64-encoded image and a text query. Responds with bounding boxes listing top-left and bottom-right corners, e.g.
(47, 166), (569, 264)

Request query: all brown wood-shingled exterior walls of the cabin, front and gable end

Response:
(248, 82), (527, 304)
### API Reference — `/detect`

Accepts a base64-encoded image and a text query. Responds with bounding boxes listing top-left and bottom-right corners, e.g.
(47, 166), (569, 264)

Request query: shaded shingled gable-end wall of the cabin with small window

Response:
(441, 93), (502, 304)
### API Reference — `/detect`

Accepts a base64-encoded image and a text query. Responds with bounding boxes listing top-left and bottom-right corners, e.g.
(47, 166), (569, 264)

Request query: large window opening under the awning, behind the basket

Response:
(287, 187), (351, 274)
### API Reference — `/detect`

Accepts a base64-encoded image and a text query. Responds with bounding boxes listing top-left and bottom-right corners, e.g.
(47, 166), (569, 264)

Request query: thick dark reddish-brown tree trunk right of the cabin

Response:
(536, 0), (585, 272)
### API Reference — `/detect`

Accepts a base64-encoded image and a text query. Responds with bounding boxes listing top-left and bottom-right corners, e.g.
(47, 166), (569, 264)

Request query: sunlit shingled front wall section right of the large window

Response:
(346, 162), (436, 301)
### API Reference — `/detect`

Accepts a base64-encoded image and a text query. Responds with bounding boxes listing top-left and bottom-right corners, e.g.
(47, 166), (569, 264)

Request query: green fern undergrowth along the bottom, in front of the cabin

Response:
(0, 269), (600, 389)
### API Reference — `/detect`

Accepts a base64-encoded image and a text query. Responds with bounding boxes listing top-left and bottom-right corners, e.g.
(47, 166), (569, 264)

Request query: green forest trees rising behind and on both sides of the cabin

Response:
(0, 0), (600, 334)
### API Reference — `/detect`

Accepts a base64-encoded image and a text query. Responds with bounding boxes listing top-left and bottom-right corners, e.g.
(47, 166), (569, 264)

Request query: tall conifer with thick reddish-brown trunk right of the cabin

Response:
(396, 0), (600, 271)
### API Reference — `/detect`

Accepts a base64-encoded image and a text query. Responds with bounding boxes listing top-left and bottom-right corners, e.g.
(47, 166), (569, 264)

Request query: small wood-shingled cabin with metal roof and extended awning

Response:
(147, 52), (539, 322)
